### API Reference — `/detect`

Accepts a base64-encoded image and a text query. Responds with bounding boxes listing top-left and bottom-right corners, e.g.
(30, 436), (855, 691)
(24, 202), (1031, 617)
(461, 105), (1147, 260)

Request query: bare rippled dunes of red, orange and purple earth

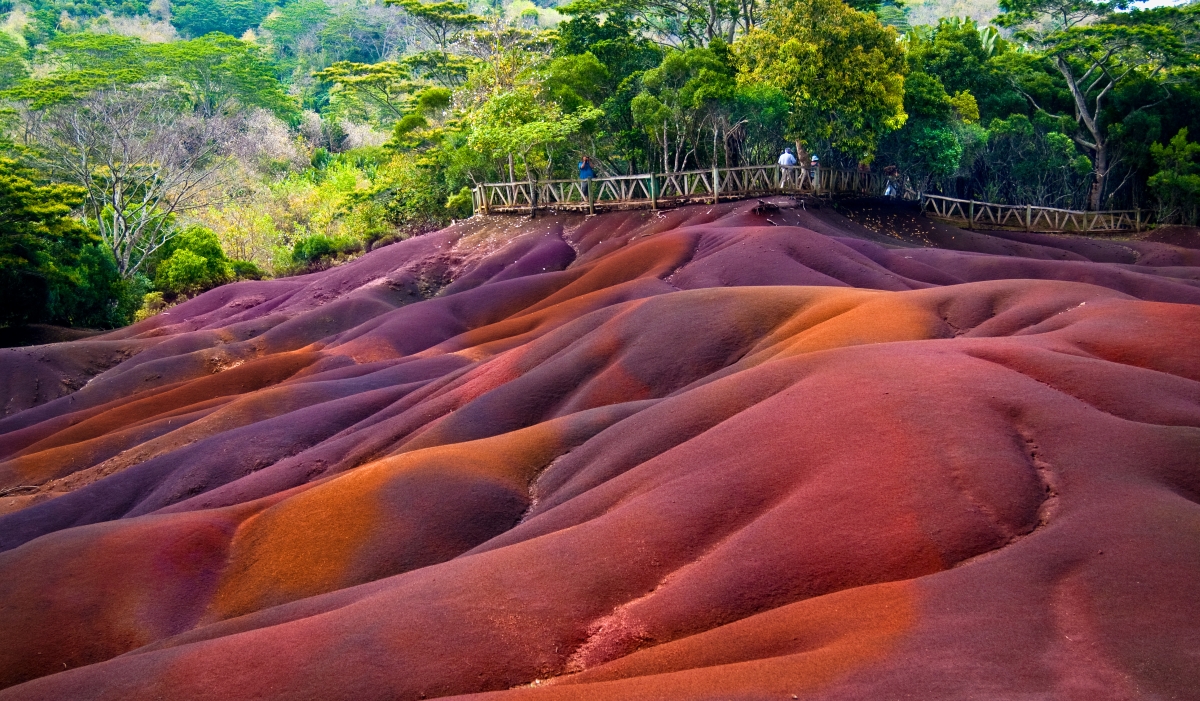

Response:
(0, 200), (1200, 701)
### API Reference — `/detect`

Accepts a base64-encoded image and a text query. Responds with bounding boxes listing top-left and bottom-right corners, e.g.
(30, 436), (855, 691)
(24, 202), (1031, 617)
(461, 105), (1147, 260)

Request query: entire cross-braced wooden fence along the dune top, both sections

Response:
(472, 166), (1148, 233)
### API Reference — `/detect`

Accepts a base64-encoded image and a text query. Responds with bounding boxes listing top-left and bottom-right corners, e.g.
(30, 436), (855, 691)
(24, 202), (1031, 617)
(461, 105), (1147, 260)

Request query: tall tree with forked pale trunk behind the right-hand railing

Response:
(997, 0), (1200, 210)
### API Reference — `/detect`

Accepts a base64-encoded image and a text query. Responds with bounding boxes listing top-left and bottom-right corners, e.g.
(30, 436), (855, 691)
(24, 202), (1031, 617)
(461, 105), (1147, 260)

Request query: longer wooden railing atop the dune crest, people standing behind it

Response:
(473, 166), (887, 214)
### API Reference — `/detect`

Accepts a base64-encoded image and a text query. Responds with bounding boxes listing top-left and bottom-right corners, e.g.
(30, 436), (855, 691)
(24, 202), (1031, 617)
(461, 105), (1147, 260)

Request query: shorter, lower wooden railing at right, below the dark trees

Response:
(920, 194), (1151, 234)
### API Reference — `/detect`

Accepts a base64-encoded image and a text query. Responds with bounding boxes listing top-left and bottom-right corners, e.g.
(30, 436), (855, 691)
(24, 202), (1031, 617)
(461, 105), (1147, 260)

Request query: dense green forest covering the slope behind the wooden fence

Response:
(0, 0), (1200, 328)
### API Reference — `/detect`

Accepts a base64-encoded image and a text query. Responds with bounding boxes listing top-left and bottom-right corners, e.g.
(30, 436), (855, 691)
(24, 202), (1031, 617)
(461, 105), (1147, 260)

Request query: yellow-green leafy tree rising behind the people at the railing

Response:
(734, 0), (907, 161)
